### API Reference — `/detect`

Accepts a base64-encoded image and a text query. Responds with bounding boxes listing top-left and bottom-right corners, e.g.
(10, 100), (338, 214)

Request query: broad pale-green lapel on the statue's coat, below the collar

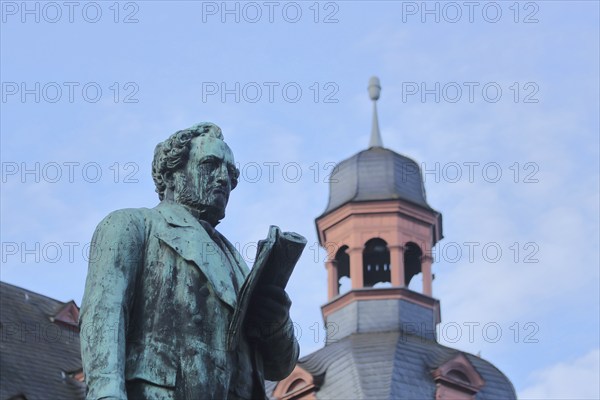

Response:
(155, 201), (244, 308)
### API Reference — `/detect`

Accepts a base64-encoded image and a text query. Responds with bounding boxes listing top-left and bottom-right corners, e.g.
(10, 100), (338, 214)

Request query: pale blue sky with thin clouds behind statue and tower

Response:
(1, 1), (600, 398)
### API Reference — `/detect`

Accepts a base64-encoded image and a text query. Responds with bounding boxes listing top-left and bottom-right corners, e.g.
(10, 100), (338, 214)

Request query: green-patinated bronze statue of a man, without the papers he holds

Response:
(80, 123), (299, 400)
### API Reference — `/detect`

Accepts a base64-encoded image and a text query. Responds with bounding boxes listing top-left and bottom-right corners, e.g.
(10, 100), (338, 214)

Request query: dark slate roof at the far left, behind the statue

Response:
(0, 282), (85, 400)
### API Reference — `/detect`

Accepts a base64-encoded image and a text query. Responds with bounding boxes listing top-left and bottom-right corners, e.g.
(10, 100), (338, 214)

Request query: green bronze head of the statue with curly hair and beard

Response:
(152, 122), (239, 226)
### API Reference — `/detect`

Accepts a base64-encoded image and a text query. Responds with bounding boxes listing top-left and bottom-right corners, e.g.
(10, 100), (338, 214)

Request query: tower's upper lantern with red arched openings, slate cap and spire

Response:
(315, 77), (442, 339)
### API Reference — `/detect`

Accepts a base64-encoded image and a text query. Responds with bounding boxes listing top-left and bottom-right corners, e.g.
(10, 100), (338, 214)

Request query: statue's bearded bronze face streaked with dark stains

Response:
(174, 136), (235, 225)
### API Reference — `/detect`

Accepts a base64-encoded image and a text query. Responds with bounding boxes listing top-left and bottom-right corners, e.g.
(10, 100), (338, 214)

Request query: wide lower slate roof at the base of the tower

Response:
(267, 331), (516, 400)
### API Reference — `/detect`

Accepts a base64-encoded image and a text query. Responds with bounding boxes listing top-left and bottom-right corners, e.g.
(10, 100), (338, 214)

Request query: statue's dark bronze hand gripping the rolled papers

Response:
(246, 285), (292, 339)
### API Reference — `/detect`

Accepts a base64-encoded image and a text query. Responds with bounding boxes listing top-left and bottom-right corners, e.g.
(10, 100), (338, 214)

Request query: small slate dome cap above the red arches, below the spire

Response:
(323, 147), (431, 214)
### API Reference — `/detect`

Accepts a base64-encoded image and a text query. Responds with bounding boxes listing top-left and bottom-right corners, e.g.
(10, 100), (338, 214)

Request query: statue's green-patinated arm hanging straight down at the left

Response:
(79, 210), (144, 400)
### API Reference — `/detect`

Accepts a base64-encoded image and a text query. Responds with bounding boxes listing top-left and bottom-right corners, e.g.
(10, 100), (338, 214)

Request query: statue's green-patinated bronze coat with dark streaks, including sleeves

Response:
(80, 201), (298, 399)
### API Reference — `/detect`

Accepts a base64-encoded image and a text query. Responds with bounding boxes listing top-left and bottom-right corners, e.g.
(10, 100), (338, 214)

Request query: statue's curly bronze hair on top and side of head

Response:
(152, 122), (239, 200)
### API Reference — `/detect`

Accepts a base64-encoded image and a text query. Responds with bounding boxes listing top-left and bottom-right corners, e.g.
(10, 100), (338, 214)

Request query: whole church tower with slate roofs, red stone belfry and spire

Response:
(265, 77), (516, 400)
